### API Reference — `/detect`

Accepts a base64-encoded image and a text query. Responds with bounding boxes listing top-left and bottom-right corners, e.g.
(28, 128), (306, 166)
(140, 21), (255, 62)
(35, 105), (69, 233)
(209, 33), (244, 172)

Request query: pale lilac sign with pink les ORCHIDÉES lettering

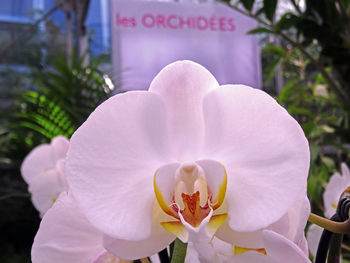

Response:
(111, 0), (261, 90)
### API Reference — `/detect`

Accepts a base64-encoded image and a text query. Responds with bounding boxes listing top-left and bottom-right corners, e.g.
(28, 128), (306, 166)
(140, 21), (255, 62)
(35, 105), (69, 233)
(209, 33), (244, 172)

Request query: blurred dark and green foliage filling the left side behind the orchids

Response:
(0, 16), (114, 263)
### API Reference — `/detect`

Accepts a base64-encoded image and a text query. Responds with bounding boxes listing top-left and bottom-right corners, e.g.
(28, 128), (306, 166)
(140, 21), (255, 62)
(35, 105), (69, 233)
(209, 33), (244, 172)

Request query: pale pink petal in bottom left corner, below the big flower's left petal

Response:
(32, 192), (103, 263)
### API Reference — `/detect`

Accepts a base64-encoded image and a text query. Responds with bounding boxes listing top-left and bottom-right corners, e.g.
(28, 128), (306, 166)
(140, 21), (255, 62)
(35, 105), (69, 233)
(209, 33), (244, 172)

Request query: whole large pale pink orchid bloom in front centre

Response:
(67, 61), (309, 259)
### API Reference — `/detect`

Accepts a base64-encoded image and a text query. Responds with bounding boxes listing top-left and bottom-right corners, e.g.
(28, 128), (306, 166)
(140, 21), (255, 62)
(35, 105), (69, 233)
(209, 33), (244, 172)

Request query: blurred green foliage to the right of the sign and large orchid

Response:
(222, 0), (350, 262)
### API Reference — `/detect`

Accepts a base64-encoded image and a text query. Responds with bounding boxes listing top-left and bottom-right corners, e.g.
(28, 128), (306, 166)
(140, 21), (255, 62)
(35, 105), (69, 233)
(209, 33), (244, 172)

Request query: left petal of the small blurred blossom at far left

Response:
(21, 144), (55, 184)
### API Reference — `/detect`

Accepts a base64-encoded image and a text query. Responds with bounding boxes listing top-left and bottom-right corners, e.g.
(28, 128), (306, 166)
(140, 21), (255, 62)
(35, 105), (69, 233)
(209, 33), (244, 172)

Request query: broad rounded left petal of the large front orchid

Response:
(66, 91), (171, 240)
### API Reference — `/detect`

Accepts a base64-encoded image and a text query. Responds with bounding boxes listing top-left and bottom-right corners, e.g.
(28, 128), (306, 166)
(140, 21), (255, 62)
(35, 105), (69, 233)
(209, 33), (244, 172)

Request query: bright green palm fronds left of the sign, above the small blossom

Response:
(6, 53), (111, 160)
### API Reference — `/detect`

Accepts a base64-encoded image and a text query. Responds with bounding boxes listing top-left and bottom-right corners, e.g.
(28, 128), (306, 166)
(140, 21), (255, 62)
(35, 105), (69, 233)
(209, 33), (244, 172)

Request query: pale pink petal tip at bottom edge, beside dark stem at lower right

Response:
(262, 230), (311, 263)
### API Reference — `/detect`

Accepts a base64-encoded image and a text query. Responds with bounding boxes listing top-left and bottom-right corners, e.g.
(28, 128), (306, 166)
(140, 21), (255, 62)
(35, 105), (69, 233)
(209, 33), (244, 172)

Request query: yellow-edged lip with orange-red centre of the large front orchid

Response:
(154, 160), (227, 240)
